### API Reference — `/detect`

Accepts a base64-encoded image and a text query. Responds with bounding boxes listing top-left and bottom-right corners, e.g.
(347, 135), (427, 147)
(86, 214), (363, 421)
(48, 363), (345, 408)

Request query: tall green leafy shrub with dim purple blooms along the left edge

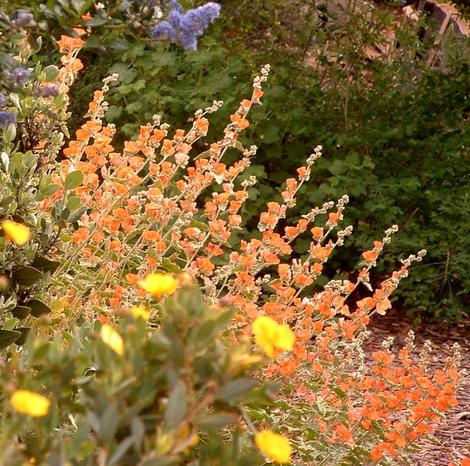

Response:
(0, 14), (83, 348)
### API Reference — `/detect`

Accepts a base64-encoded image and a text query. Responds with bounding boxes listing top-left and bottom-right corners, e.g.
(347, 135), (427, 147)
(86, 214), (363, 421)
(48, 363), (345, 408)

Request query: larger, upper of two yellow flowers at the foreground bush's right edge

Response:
(253, 316), (295, 358)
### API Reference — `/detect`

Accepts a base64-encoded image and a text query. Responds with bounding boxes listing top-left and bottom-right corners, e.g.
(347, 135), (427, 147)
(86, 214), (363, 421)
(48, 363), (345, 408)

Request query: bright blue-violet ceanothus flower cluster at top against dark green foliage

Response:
(150, 0), (220, 50)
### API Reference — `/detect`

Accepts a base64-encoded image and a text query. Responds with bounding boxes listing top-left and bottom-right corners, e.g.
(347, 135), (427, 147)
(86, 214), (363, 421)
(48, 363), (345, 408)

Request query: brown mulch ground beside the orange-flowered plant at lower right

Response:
(367, 312), (470, 466)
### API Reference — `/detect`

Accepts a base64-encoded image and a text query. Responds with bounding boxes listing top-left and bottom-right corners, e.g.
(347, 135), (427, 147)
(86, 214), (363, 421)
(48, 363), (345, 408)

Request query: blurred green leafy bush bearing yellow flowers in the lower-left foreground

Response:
(0, 288), (273, 466)
